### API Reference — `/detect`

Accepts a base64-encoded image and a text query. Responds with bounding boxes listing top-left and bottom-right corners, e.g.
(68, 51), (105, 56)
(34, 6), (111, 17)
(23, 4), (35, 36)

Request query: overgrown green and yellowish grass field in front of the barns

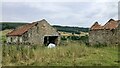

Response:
(2, 41), (118, 66)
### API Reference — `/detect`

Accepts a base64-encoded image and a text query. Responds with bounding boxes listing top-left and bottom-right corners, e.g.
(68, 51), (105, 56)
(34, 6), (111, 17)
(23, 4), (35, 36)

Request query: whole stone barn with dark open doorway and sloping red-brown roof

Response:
(6, 19), (60, 45)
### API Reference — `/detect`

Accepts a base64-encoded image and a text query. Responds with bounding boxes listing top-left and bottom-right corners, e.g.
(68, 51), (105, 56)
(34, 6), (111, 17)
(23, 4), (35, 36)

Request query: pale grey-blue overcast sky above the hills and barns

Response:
(0, 0), (118, 27)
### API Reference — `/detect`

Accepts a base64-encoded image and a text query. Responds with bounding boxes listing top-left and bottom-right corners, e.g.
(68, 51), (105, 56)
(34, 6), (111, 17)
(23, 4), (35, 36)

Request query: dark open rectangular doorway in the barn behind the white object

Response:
(44, 36), (58, 46)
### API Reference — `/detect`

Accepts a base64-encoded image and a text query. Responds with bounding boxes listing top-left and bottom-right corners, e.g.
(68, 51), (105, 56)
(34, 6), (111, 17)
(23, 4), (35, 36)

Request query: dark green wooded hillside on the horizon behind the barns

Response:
(0, 22), (89, 34)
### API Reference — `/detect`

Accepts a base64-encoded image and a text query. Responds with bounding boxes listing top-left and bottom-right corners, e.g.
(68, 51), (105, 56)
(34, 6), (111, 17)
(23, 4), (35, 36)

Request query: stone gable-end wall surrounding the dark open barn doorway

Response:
(24, 21), (60, 45)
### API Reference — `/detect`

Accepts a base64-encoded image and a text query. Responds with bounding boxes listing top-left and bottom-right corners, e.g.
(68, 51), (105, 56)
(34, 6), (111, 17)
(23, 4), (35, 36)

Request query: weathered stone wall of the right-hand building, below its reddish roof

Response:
(89, 29), (120, 45)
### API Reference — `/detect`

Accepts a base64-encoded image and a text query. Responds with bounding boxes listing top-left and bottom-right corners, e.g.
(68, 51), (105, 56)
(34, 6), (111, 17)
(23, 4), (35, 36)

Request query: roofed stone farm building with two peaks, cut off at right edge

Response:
(89, 19), (120, 45)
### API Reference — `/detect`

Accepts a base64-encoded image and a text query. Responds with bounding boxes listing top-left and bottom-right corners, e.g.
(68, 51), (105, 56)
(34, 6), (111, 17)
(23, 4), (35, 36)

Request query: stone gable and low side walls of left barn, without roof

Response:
(7, 20), (60, 45)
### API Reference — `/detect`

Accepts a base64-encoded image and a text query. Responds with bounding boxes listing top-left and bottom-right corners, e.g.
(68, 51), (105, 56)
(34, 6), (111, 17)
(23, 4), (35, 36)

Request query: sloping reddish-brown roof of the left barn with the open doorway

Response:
(7, 22), (36, 36)
